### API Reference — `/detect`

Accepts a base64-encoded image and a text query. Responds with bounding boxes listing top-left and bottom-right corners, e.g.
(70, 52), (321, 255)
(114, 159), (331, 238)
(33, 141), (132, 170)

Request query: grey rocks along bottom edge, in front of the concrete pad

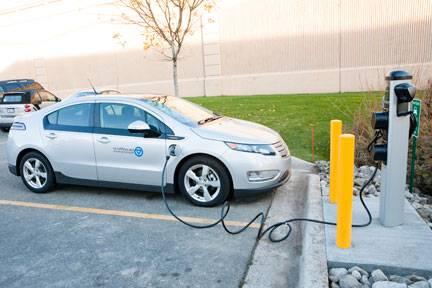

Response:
(329, 266), (432, 288)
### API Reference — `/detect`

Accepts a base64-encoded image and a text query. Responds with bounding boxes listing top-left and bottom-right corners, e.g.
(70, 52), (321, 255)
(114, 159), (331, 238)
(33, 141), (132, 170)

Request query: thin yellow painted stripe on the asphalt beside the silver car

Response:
(0, 200), (260, 228)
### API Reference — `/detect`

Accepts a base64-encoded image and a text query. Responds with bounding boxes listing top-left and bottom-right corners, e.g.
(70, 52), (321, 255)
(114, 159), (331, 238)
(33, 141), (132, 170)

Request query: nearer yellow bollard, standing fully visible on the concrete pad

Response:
(336, 134), (355, 249)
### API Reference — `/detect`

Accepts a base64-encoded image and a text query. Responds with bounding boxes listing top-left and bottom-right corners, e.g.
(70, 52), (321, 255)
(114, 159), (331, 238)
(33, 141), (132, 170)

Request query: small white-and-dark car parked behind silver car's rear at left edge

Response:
(0, 89), (61, 132)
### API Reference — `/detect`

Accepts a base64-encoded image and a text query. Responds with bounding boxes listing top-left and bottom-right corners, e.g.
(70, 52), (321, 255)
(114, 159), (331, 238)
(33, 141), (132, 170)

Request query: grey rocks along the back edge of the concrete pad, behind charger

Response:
(316, 161), (432, 229)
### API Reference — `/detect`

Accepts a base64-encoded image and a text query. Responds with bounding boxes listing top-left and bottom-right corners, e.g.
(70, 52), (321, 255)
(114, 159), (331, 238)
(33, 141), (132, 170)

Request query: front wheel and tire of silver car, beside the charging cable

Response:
(177, 156), (231, 207)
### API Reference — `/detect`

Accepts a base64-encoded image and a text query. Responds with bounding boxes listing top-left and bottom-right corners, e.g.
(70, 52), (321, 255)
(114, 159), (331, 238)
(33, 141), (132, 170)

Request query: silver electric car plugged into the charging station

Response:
(7, 95), (291, 206)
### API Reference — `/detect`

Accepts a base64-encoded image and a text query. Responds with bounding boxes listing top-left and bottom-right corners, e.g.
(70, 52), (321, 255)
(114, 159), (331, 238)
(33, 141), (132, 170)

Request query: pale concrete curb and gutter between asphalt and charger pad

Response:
(243, 158), (328, 288)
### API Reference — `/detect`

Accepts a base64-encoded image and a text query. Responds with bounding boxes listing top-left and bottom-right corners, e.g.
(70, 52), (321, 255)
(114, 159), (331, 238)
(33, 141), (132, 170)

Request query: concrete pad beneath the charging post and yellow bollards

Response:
(324, 197), (432, 277)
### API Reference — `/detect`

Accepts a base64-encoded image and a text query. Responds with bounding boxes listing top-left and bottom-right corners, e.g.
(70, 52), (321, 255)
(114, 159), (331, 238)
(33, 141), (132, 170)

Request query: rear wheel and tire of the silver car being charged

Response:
(20, 152), (55, 193)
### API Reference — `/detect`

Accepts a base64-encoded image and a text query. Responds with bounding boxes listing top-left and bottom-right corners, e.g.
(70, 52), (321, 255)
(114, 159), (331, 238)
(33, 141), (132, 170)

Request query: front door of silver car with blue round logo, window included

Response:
(94, 102), (166, 189)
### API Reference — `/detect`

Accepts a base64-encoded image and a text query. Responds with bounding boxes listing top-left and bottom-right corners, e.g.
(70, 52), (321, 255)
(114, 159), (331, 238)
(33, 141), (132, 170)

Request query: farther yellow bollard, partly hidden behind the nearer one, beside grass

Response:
(330, 120), (342, 203)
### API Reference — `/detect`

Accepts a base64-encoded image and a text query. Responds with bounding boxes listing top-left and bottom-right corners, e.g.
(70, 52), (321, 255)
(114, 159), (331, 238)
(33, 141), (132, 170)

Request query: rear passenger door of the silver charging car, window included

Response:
(42, 102), (97, 180)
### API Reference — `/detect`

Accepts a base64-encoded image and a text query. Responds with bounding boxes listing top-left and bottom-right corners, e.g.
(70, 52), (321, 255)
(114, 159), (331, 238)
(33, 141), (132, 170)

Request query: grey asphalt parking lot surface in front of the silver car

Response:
(0, 132), (284, 287)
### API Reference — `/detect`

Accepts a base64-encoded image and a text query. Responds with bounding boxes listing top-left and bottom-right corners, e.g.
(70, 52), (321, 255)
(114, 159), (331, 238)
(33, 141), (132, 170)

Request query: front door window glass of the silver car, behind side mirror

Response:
(95, 103), (174, 137)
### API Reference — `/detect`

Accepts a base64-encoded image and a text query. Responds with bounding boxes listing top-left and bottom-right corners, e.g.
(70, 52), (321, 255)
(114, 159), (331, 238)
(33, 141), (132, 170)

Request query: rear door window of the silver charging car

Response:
(44, 103), (93, 132)
